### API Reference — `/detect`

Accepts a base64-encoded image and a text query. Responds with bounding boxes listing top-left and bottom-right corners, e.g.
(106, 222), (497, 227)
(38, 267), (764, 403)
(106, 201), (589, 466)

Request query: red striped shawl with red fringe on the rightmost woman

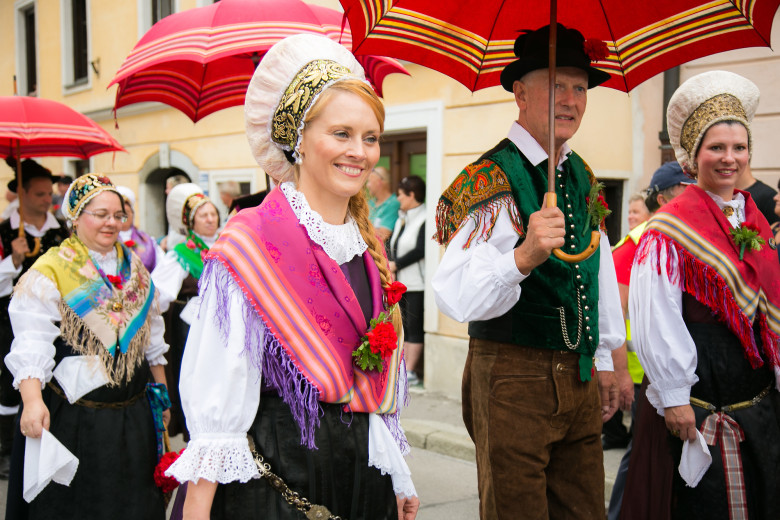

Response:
(634, 186), (780, 368)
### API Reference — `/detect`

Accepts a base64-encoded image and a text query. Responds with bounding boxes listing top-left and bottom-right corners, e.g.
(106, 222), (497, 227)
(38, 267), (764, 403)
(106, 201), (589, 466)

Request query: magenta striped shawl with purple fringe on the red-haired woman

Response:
(206, 188), (403, 449)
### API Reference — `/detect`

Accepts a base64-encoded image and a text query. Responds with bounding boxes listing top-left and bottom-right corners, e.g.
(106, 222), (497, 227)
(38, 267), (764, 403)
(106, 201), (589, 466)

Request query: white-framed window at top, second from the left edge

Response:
(62, 0), (89, 88)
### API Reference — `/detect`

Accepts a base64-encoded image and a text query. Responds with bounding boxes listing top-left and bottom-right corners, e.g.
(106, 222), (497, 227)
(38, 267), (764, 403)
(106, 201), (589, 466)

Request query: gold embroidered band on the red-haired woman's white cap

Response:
(271, 60), (352, 151)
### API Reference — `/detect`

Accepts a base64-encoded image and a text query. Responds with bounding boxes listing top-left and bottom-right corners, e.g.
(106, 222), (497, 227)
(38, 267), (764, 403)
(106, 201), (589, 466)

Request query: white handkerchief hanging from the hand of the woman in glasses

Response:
(22, 430), (79, 503)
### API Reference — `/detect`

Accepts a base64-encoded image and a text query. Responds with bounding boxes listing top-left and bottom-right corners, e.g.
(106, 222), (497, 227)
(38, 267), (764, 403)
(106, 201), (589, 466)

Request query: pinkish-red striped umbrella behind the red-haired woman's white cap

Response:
(109, 0), (408, 122)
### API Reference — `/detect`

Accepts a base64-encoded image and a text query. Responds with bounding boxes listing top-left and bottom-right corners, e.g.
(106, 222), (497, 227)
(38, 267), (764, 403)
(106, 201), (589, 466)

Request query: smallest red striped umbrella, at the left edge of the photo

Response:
(0, 96), (125, 159)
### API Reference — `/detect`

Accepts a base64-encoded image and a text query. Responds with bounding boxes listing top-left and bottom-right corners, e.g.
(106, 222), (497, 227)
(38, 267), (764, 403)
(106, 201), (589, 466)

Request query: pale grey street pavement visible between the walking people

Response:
(0, 388), (624, 520)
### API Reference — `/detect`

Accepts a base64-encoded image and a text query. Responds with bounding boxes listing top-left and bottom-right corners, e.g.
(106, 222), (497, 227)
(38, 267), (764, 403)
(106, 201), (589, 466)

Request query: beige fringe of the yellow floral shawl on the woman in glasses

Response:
(59, 295), (150, 387)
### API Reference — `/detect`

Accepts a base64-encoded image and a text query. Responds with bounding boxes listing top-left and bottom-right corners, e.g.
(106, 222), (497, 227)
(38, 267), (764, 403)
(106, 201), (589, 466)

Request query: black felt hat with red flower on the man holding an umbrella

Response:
(501, 24), (609, 92)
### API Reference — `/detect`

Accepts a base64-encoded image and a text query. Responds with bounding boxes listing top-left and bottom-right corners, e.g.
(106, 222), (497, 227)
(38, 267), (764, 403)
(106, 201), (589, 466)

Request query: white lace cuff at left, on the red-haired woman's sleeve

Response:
(165, 436), (260, 484)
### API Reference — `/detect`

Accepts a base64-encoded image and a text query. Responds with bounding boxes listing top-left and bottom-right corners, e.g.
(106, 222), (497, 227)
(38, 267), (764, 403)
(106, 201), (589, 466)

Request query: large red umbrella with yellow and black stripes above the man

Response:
(340, 0), (780, 92)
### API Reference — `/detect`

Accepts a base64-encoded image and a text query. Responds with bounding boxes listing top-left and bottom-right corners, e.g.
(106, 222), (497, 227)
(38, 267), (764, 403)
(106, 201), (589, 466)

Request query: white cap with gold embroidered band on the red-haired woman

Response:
(244, 34), (365, 182)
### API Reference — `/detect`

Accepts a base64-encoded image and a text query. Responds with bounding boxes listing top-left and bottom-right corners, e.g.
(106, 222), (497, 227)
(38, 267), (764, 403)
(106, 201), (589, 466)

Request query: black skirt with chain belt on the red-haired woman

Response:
(211, 394), (398, 520)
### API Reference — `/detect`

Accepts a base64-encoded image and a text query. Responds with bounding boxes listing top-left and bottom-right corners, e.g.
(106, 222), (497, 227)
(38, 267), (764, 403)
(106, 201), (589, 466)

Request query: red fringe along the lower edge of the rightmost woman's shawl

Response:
(634, 229), (780, 368)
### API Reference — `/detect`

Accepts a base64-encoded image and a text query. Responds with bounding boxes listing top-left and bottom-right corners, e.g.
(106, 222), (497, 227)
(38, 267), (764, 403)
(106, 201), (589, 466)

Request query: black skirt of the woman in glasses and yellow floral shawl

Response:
(6, 346), (165, 520)
